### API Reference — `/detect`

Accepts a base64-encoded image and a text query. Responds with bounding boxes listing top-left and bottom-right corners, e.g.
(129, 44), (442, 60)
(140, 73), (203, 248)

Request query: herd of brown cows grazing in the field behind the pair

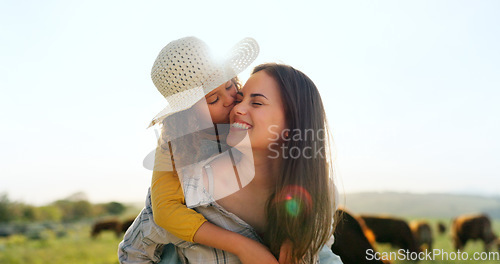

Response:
(91, 209), (500, 264)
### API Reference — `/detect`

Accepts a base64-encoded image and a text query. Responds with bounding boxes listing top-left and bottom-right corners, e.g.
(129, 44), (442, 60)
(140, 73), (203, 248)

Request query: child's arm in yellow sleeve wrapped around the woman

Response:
(151, 147), (278, 264)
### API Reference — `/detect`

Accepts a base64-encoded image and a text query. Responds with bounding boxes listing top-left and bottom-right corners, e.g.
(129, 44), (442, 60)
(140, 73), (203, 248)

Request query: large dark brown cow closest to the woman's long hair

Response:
(331, 209), (390, 264)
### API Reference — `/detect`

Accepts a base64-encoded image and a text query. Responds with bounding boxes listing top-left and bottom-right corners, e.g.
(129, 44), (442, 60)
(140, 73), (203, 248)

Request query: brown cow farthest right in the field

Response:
(451, 214), (500, 251)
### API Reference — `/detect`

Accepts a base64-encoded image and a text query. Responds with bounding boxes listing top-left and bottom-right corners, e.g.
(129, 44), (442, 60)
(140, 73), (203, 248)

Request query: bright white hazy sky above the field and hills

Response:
(0, 0), (500, 204)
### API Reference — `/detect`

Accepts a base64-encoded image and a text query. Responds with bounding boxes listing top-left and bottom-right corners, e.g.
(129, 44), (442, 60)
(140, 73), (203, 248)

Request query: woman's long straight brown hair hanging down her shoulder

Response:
(252, 63), (335, 263)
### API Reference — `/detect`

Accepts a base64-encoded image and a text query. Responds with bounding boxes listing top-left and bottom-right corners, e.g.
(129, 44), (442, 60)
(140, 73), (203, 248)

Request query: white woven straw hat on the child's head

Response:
(149, 37), (259, 126)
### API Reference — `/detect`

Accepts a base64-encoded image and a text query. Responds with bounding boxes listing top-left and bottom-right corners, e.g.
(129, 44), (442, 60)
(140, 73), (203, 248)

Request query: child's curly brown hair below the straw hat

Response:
(159, 77), (241, 168)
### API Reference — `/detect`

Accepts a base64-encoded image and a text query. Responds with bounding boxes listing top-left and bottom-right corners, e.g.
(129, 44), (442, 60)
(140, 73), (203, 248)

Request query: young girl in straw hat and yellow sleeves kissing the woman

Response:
(119, 37), (278, 263)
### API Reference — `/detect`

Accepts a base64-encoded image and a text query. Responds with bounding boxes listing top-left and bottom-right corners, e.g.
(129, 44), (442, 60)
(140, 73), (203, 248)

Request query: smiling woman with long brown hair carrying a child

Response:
(120, 64), (341, 263)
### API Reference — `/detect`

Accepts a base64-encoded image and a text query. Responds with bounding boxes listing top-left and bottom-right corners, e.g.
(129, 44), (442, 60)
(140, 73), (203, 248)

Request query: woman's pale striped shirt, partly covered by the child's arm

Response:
(118, 152), (342, 264)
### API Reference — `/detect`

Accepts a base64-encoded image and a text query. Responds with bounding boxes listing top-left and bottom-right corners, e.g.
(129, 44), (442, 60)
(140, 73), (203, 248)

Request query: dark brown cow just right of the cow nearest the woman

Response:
(361, 215), (420, 253)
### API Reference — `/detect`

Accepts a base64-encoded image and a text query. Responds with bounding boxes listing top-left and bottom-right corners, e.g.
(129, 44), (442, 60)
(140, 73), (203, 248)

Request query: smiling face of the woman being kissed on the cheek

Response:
(227, 71), (286, 151)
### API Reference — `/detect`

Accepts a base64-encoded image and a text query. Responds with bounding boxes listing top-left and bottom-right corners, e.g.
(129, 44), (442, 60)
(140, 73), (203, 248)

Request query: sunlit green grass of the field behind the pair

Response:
(0, 219), (500, 264)
